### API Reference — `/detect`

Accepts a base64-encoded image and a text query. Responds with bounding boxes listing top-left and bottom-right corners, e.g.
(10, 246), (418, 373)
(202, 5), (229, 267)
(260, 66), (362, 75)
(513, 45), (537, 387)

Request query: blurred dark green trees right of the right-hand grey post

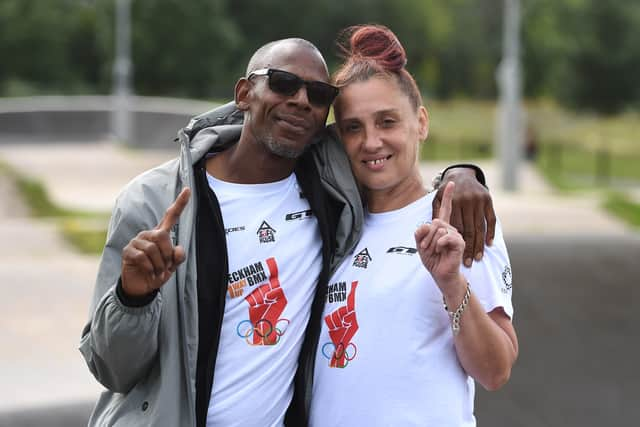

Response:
(524, 0), (640, 114)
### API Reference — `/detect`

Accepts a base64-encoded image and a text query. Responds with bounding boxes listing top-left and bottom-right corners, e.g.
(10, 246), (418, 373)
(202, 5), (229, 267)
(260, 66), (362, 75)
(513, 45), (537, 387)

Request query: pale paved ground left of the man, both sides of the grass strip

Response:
(0, 144), (172, 412)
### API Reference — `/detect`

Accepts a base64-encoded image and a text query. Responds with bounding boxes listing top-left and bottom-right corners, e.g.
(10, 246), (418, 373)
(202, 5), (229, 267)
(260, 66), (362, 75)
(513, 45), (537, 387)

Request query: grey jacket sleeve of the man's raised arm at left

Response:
(80, 186), (162, 393)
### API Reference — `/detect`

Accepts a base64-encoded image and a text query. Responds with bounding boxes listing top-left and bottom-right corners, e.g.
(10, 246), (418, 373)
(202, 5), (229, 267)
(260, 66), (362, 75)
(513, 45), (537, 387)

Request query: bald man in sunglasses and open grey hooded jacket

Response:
(80, 39), (490, 426)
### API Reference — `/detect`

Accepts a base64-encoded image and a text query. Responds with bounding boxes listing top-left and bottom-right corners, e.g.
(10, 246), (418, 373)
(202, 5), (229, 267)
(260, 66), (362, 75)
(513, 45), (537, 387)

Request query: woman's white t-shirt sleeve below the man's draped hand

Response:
(462, 221), (513, 319)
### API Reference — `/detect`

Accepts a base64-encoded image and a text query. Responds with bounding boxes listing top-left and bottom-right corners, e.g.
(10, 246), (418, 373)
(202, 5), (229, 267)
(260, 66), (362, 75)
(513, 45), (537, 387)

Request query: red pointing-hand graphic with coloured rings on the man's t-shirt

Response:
(236, 258), (289, 345)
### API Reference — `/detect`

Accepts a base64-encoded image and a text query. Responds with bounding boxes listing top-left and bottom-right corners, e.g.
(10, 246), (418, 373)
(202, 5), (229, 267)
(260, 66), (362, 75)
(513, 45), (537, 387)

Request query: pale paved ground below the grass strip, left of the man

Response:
(0, 177), (105, 414)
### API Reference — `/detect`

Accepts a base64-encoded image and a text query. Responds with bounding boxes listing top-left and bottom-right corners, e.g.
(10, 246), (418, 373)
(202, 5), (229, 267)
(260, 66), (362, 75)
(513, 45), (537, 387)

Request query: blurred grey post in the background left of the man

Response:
(111, 0), (131, 144)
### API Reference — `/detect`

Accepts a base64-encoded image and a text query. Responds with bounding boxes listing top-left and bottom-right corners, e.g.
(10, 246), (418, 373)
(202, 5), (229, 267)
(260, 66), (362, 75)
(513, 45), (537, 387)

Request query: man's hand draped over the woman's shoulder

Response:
(433, 167), (496, 267)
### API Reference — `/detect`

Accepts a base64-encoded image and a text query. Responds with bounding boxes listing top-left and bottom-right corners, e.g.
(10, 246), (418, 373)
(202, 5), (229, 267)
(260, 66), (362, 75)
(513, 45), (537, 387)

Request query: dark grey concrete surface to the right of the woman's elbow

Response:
(476, 234), (640, 427)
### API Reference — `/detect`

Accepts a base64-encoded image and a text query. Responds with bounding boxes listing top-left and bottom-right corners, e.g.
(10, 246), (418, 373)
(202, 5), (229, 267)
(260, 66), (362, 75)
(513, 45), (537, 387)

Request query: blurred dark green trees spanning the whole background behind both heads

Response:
(0, 0), (640, 114)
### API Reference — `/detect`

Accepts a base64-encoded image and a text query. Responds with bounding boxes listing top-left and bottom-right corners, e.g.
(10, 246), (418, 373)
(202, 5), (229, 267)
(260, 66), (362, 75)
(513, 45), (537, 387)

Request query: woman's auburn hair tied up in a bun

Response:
(333, 24), (422, 110)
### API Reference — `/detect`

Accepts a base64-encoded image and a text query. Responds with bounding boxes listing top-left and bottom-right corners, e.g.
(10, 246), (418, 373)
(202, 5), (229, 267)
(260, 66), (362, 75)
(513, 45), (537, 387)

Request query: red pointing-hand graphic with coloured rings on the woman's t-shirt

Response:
(322, 281), (358, 368)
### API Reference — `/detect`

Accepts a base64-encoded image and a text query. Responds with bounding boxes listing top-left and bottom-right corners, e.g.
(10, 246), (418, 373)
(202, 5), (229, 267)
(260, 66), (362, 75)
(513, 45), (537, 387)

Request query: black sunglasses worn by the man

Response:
(247, 68), (338, 107)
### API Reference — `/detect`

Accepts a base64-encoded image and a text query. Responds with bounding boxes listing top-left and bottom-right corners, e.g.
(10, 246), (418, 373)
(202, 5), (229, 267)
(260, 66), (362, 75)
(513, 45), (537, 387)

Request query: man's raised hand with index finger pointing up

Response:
(121, 188), (191, 297)
